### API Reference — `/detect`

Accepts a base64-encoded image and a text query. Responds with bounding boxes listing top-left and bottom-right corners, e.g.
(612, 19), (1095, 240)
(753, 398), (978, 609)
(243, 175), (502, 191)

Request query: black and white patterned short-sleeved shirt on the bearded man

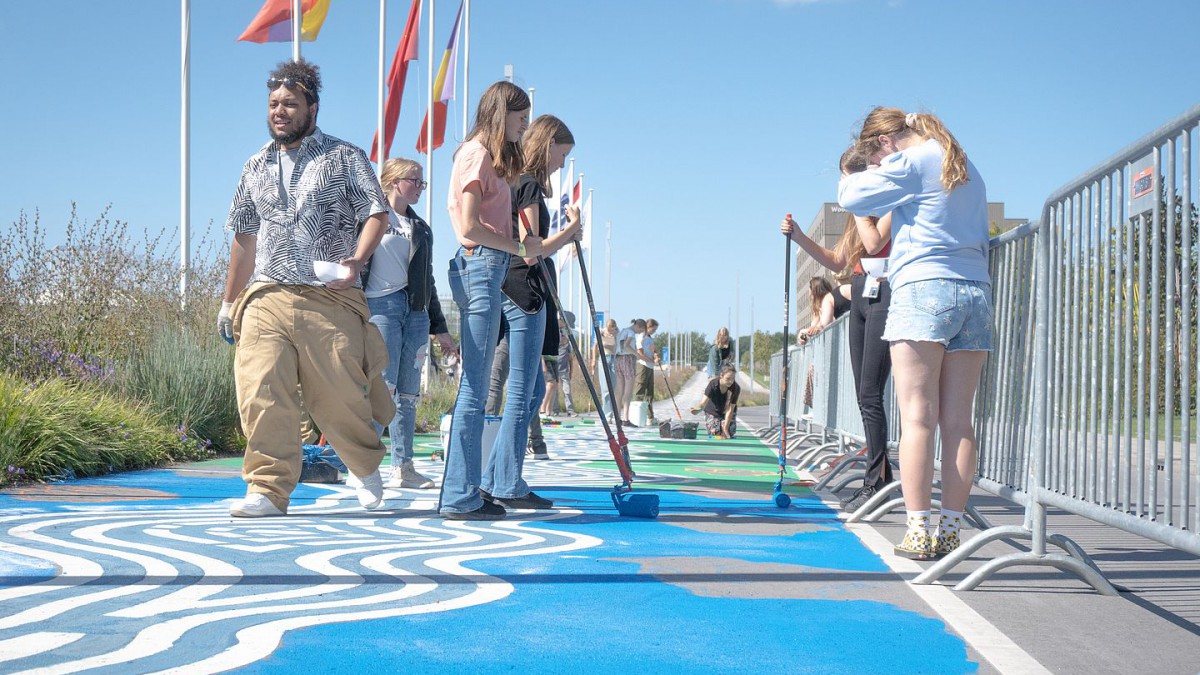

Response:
(226, 129), (388, 287)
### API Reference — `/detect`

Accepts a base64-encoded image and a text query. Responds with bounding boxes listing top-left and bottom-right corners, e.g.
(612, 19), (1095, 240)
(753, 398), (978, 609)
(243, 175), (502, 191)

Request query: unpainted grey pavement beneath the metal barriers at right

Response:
(738, 406), (1200, 674)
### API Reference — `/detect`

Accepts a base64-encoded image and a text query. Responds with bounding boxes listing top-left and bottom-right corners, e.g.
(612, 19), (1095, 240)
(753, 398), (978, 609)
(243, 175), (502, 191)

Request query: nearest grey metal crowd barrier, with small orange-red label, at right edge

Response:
(918, 106), (1200, 592)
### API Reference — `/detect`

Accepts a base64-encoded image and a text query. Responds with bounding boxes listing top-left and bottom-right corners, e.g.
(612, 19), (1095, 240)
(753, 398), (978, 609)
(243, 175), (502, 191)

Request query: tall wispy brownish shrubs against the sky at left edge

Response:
(0, 209), (228, 372)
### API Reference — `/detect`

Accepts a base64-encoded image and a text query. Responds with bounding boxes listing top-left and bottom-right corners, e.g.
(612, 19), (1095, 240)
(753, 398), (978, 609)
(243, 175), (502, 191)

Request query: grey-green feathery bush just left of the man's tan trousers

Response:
(110, 325), (245, 449)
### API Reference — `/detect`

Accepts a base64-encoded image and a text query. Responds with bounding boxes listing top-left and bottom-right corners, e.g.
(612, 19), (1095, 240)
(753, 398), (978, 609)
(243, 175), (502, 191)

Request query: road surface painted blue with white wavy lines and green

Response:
(0, 422), (990, 674)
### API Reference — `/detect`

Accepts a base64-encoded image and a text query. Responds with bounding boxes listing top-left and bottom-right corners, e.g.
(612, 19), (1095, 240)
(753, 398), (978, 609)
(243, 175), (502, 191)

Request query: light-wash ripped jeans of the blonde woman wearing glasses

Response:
(367, 289), (430, 471)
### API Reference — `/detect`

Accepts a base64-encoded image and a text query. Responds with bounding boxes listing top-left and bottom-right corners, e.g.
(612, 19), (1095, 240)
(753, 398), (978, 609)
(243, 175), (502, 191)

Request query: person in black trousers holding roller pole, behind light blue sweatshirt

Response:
(780, 148), (894, 510)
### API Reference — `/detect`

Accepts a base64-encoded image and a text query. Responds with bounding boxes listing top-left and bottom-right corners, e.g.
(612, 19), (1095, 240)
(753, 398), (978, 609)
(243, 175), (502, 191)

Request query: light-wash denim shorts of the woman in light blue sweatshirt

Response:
(883, 279), (992, 352)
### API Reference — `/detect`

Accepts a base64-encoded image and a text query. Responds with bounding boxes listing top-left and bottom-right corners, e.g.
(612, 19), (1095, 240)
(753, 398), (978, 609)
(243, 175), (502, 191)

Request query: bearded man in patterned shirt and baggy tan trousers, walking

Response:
(217, 61), (396, 518)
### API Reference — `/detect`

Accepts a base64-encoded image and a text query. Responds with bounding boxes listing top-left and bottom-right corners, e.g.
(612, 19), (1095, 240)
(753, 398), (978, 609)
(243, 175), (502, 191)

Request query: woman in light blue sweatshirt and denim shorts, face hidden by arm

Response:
(838, 108), (992, 560)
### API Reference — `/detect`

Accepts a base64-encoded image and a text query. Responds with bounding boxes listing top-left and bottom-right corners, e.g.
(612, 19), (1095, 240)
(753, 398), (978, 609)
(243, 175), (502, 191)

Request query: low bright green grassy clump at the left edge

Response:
(0, 372), (212, 485)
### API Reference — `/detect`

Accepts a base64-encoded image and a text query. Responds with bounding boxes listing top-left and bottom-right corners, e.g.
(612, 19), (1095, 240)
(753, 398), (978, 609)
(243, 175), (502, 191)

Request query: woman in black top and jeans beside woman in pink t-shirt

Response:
(480, 115), (583, 508)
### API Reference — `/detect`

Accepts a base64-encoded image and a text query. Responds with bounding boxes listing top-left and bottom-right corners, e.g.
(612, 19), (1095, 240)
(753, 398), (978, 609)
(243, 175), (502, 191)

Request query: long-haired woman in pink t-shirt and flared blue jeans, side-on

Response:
(438, 82), (541, 520)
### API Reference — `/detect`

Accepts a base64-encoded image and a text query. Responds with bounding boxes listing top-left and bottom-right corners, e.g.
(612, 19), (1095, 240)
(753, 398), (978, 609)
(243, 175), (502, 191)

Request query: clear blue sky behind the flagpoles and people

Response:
(0, 0), (1200, 335)
